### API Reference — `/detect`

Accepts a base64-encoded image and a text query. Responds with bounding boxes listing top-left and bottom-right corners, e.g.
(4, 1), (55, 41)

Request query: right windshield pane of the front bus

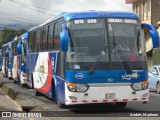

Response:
(108, 19), (146, 62)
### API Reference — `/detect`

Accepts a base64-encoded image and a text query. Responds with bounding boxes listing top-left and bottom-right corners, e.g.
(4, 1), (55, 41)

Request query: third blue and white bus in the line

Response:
(2, 41), (12, 79)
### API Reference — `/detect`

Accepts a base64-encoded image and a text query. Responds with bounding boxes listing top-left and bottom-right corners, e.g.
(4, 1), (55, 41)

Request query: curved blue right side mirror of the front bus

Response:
(142, 23), (159, 48)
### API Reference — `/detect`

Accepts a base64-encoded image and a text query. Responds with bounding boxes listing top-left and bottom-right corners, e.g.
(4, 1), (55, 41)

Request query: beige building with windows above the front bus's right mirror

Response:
(130, 0), (160, 28)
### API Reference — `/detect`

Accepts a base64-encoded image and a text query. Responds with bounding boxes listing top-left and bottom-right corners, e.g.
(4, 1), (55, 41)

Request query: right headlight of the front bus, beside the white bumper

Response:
(131, 81), (148, 91)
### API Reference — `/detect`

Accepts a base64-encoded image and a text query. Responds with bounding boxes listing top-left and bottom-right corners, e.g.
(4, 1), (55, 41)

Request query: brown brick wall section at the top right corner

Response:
(151, 0), (160, 28)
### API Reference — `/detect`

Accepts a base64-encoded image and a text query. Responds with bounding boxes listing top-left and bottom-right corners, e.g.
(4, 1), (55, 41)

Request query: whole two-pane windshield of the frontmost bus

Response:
(66, 19), (146, 70)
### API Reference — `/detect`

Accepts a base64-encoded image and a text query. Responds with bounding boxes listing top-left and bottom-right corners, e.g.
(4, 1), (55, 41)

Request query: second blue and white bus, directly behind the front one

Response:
(11, 32), (28, 86)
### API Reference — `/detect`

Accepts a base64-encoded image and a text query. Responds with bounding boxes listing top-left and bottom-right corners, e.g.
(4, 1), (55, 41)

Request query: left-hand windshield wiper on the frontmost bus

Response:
(89, 44), (109, 75)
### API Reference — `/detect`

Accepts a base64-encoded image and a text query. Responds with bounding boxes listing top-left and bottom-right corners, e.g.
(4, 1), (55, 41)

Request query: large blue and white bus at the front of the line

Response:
(27, 11), (159, 107)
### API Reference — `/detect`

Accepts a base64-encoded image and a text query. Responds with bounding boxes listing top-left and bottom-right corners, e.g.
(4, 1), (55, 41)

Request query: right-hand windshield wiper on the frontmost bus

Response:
(113, 32), (131, 74)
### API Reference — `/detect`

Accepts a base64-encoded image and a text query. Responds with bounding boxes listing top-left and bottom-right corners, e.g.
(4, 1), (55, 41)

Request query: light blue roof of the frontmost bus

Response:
(29, 11), (140, 31)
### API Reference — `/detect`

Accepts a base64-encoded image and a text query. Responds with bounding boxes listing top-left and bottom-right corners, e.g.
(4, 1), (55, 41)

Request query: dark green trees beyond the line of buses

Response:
(0, 28), (27, 48)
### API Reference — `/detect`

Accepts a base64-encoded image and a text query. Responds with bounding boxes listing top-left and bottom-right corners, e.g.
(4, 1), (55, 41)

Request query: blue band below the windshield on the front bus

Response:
(65, 70), (148, 84)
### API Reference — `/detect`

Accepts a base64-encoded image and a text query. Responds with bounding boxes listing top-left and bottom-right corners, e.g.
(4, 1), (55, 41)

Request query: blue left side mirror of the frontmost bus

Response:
(60, 24), (69, 52)
